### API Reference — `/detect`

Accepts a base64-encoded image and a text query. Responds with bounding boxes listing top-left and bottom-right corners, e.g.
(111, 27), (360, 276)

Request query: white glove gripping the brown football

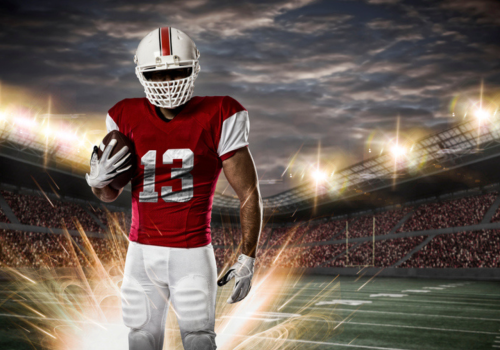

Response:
(85, 139), (132, 188)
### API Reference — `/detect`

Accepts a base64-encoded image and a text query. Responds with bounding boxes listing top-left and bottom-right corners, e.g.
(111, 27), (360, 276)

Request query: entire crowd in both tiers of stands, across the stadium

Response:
(0, 190), (500, 269)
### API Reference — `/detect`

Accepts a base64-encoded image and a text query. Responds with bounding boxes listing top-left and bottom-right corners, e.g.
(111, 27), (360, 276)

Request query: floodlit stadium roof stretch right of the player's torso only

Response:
(214, 119), (500, 213)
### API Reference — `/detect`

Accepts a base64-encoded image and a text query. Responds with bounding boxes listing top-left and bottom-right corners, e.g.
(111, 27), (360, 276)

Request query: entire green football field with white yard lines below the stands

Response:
(0, 276), (500, 350)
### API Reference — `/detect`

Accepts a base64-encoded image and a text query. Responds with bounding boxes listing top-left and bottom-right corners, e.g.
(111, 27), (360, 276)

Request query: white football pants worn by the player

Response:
(121, 242), (217, 350)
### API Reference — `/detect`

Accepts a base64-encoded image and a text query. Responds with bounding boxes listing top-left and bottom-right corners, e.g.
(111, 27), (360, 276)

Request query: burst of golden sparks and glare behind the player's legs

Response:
(4, 211), (354, 350)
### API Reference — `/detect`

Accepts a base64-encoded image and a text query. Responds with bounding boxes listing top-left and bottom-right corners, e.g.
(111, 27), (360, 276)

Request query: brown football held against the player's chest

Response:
(97, 130), (136, 190)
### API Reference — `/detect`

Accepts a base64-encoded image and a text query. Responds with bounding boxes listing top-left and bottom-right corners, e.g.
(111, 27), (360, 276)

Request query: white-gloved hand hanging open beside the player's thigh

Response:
(217, 254), (255, 304)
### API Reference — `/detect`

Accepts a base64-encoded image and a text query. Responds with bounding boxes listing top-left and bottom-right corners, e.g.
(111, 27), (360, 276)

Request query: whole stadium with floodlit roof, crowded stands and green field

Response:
(0, 94), (500, 349)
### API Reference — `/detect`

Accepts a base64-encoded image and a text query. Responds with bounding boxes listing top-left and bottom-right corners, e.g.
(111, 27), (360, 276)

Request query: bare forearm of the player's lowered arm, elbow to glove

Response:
(240, 190), (262, 258)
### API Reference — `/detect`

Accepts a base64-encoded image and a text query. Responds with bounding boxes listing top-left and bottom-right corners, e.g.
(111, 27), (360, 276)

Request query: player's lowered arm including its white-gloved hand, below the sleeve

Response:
(217, 147), (262, 304)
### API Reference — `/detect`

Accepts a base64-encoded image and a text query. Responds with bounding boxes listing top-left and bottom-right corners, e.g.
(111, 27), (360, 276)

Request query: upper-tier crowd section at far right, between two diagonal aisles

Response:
(398, 192), (498, 232)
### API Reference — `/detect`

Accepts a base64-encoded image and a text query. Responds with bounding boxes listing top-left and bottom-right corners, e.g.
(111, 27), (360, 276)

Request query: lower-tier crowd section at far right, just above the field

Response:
(401, 230), (500, 268)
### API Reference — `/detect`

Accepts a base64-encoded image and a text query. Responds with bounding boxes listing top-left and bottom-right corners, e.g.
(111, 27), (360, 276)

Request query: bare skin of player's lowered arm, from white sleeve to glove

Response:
(222, 147), (262, 258)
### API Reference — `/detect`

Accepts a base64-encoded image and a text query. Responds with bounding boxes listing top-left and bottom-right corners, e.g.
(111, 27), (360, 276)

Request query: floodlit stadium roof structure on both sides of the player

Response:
(0, 115), (500, 217)
